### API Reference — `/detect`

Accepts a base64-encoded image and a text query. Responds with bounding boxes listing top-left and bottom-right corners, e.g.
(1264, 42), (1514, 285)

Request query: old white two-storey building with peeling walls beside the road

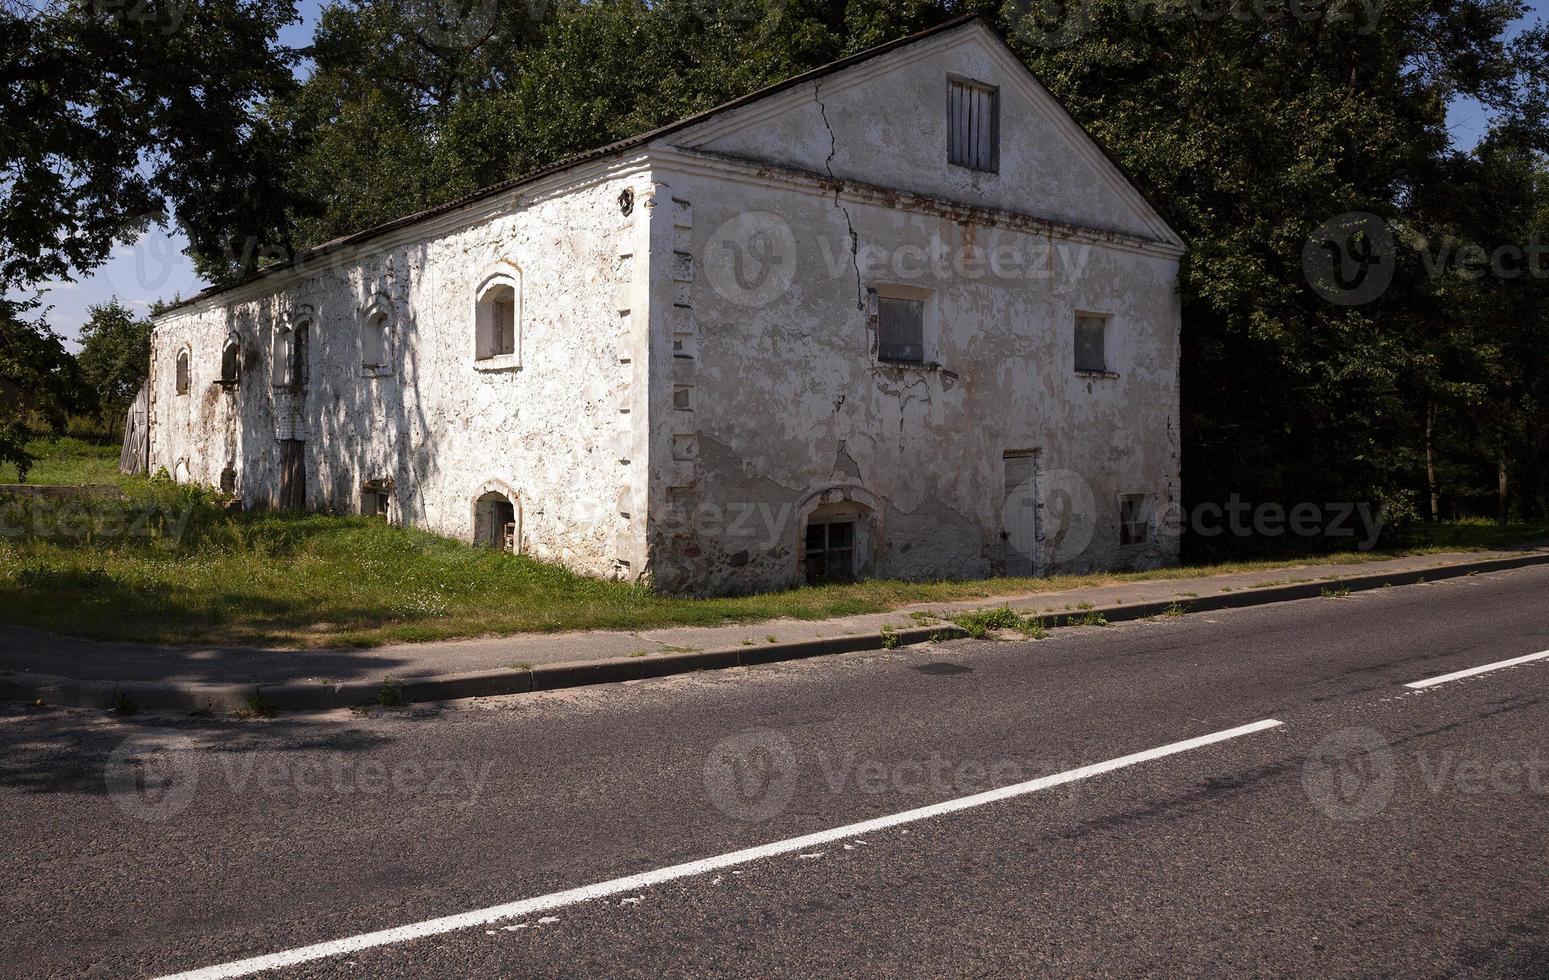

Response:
(149, 20), (1183, 591)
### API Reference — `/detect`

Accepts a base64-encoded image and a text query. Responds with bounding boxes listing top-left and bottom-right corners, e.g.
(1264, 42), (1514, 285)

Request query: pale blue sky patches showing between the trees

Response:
(21, 0), (1549, 350)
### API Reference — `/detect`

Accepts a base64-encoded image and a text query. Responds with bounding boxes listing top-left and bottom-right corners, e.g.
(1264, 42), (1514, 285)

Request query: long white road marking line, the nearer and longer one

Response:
(161, 718), (1283, 980)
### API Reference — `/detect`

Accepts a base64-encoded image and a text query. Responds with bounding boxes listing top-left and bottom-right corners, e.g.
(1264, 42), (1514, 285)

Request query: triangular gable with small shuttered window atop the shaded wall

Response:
(657, 20), (1182, 248)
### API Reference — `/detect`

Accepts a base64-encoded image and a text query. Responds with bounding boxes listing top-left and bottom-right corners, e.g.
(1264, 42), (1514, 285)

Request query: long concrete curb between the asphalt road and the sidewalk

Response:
(0, 553), (1549, 714)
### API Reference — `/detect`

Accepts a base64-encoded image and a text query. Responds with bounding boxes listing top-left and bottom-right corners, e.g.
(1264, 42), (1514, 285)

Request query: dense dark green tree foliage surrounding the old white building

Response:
(0, 0), (1549, 519)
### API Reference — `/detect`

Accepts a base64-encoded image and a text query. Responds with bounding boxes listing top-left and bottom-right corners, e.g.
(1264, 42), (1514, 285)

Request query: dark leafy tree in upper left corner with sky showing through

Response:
(0, 0), (296, 294)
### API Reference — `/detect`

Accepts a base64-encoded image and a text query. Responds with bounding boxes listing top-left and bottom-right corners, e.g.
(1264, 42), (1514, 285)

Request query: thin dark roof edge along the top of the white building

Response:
(152, 14), (1176, 320)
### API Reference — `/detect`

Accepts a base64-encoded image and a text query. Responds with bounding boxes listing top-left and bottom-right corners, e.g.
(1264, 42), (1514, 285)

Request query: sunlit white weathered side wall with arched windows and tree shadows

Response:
(152, 167), (649, 576)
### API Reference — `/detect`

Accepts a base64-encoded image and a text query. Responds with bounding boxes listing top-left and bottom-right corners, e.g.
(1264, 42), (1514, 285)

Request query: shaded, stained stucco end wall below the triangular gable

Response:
(651, 170), (1179, 591)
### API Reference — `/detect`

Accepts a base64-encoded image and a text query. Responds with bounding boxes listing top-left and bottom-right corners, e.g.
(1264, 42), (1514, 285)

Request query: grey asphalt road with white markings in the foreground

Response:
(9, 568), (1549, 977)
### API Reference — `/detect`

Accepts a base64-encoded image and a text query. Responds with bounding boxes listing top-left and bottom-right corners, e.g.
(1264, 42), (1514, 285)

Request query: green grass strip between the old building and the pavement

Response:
(0, 440), (1549, 650)
